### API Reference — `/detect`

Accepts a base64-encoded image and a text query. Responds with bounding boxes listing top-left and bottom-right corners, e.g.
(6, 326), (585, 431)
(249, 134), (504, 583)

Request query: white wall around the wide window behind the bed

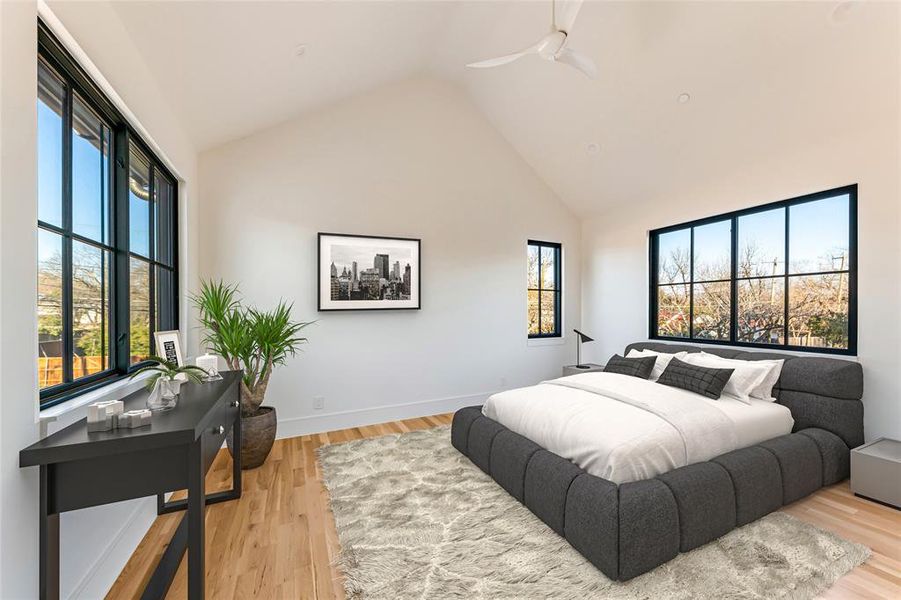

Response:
(582, 117), (901, 440)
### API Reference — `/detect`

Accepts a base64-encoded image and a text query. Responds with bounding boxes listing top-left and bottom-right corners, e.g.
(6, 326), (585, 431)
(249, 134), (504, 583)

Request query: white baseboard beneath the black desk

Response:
(68, 496), (156, 600)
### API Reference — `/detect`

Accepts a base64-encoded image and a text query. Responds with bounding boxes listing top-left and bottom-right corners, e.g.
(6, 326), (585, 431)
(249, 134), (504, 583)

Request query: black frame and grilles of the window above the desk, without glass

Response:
(35, 19), (180, 410)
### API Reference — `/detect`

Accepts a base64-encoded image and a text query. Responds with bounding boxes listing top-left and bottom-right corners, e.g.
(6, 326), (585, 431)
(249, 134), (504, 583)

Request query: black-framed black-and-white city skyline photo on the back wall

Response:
(318, 233), (421, 311)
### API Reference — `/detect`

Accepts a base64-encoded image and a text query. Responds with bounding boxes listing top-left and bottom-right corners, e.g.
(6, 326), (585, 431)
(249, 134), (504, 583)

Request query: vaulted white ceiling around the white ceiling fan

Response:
(103, 0), (899, 215)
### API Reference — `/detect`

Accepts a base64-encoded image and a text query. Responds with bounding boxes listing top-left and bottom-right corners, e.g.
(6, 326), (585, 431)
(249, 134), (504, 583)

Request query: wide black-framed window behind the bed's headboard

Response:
(650, 185), (857, 354)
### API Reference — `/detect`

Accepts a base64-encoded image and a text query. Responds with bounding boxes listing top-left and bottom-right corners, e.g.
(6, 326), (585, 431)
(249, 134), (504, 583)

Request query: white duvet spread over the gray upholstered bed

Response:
(482, 372), (794, 483)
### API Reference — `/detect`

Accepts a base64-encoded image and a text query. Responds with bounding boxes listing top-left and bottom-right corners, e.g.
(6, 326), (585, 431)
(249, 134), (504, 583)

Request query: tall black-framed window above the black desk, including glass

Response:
(37, 23), (178, 408)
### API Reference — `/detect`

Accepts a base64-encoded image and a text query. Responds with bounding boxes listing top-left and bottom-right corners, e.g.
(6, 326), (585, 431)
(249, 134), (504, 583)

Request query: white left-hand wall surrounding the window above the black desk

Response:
(0, 1), (197, 600)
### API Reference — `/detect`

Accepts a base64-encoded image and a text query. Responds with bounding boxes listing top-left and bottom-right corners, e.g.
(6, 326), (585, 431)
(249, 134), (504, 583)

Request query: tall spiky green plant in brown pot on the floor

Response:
(193, 281), (310, 469)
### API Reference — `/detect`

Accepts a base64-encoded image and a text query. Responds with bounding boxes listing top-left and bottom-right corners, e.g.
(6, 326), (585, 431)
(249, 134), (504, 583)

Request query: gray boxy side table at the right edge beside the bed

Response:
(851, 438), (901, 508)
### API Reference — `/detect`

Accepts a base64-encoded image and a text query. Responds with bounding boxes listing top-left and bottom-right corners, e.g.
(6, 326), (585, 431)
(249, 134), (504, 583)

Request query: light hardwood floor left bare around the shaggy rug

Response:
(107, 414), (901, 600)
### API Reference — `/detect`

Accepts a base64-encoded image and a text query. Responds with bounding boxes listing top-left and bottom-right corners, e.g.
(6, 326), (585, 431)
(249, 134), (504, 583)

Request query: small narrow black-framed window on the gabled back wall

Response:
(527, 240), (563, 338)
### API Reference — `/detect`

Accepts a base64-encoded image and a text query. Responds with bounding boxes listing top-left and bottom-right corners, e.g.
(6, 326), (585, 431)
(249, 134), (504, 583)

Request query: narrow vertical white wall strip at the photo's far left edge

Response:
(0, 2), (38, 599)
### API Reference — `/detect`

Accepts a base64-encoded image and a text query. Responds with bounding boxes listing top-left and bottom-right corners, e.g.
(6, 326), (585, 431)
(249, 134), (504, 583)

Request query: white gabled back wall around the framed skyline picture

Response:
(200, 79), (580, 436)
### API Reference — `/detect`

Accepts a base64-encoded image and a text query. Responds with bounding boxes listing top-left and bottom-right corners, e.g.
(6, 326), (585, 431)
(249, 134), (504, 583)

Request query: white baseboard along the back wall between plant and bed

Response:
(277, 392), (495, 439)
